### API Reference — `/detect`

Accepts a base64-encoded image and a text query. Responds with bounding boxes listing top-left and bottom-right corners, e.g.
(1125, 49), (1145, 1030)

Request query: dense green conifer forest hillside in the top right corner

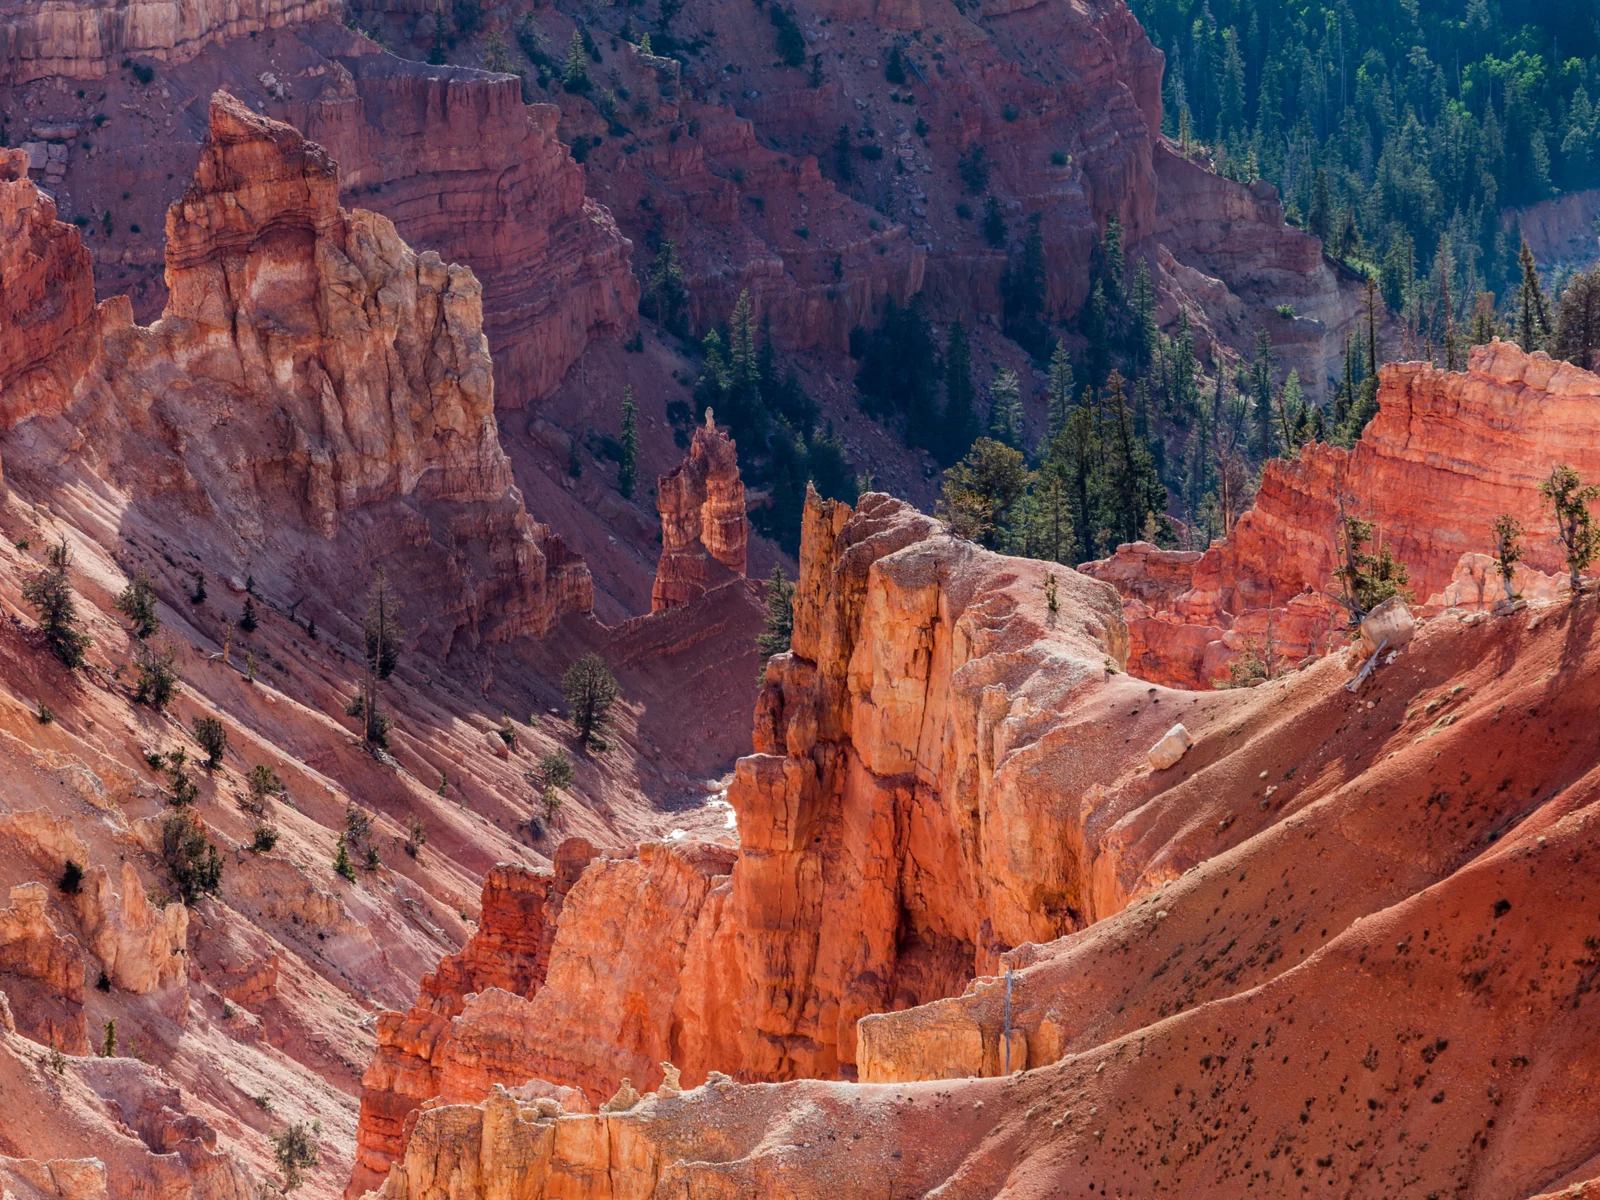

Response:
(1131, 0), (1600, 324)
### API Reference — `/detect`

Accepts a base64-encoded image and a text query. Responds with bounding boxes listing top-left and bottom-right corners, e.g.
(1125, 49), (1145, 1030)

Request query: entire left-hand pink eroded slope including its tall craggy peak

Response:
(0, 94), (758, 1200)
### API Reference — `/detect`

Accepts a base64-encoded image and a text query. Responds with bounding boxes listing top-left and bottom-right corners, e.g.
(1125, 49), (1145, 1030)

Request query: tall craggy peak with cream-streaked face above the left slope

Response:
(10, 93), (590, 656)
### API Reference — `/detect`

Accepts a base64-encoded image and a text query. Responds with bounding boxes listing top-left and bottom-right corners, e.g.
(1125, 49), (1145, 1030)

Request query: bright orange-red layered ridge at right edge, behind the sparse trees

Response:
(1083, 341), (1600, 686)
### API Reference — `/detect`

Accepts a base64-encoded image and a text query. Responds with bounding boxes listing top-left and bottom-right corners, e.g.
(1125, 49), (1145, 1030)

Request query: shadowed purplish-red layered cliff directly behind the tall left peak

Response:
(283, 56), (638, 408)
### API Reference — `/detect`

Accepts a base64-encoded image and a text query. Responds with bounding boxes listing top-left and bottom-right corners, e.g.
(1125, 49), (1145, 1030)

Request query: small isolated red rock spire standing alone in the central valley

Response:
(650, 413), (750, 613)
